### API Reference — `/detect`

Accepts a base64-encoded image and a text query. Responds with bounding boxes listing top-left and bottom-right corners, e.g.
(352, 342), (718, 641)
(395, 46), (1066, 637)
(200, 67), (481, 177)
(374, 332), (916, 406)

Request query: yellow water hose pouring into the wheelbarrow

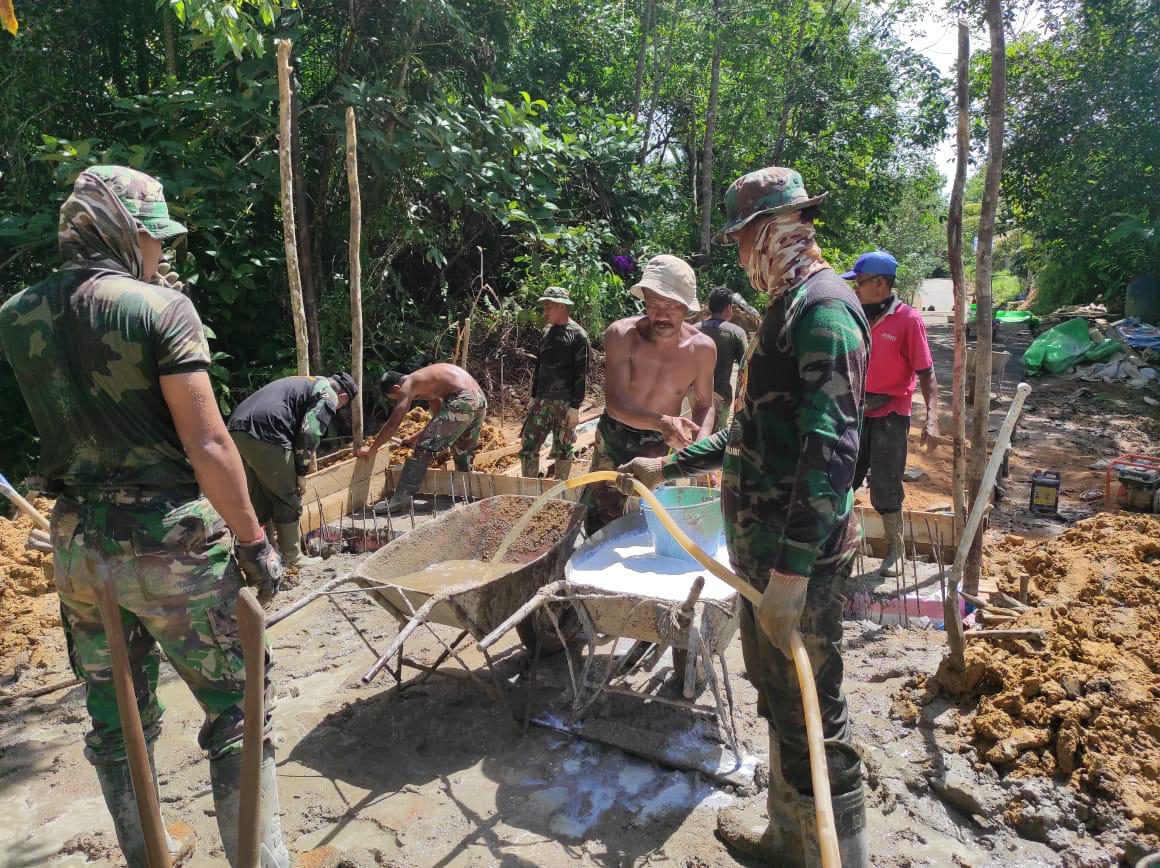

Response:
(560, 470), (842, 868)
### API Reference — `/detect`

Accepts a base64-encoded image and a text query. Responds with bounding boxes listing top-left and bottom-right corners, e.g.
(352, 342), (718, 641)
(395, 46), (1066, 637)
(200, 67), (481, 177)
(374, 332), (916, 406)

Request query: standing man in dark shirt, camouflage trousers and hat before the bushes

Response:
(520, 287), (588, 479)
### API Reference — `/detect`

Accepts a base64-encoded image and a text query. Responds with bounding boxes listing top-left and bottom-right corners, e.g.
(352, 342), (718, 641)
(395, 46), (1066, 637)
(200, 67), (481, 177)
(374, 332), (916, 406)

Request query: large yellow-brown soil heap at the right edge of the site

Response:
(927, 513), (1160, 848)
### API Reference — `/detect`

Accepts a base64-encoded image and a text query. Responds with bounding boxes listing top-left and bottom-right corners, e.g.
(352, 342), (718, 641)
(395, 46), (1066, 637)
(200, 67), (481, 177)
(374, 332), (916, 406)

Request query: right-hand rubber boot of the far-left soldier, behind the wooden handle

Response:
(210, 744), (290, 868)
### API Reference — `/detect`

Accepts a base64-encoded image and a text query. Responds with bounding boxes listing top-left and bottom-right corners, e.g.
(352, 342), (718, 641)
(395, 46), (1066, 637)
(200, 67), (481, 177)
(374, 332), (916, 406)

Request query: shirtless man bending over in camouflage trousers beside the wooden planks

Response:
(355, 362), (487, 514)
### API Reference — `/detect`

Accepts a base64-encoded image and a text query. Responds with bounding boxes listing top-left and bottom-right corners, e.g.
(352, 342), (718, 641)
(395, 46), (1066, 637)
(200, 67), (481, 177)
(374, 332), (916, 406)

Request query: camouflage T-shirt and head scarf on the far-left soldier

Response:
(0, 173), (210, 489)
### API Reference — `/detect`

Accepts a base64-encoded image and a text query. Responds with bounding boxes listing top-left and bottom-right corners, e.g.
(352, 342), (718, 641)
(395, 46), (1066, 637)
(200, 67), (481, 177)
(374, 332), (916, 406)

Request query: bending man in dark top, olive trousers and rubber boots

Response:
(226, 372), (358, 566)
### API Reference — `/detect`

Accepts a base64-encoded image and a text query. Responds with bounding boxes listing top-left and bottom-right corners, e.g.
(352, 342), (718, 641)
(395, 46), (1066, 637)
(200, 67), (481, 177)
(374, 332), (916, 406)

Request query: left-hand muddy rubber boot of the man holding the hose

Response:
(717, 728), (806, 868)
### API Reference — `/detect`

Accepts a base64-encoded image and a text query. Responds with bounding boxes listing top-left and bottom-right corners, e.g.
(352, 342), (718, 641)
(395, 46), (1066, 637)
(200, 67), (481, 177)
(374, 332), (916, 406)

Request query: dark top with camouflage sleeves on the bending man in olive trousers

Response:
(226, 377), (339, 476)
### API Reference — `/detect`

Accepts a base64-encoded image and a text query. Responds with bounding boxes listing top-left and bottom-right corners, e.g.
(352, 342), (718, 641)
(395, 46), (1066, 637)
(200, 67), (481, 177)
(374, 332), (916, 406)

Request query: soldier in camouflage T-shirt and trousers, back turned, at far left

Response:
(0, 166), (289, 868)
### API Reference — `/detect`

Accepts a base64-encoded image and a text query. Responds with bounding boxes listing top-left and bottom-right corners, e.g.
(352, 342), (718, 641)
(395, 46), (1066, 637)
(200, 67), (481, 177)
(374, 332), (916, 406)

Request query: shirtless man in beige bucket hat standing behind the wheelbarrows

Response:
(582, 254), (717, 536)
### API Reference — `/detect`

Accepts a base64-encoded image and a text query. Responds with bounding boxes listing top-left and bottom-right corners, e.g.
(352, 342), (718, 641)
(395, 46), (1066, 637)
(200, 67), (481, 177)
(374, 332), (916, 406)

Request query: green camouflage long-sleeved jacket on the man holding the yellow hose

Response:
(665, 268), (870, 578)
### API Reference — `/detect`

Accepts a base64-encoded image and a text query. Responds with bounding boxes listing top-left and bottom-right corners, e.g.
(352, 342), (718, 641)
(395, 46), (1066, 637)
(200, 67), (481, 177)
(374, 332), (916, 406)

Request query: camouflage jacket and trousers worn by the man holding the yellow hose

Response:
(664, 269), (869, 796)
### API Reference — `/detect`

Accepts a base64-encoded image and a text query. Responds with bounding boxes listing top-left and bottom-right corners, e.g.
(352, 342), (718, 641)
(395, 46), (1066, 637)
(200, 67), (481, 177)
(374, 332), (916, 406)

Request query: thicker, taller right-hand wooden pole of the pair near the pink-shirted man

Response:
(963, 0), (1007, 593)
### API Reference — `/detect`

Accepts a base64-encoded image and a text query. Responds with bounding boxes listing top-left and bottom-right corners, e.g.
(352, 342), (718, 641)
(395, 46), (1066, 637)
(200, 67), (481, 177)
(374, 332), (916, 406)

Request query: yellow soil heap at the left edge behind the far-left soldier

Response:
(0, 501), (65, 682)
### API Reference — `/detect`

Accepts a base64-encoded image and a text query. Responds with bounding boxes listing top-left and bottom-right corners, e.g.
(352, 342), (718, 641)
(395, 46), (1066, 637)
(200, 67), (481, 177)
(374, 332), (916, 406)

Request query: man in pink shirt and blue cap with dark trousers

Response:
(842, 251), (938, 576)
